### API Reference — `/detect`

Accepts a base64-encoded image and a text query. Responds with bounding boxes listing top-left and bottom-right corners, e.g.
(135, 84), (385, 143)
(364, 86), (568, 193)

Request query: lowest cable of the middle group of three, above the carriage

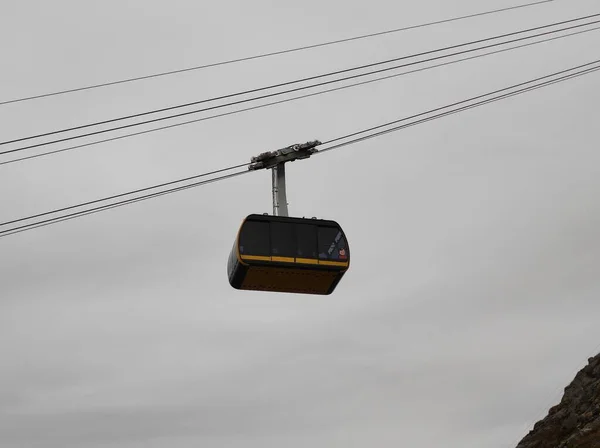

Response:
(0, 23), (600, 166)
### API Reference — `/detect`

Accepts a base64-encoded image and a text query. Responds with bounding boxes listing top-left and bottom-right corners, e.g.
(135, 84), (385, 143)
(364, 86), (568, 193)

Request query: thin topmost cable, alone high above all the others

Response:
(0, 0), (555, 106)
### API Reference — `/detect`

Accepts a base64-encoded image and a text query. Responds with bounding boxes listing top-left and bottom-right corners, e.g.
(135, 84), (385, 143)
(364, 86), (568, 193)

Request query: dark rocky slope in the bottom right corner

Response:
(517, 355), (600, 448)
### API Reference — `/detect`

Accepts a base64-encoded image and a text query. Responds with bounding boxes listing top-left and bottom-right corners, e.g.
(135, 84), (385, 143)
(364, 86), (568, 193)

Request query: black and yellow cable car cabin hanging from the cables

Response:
(227, 215), (350, 295)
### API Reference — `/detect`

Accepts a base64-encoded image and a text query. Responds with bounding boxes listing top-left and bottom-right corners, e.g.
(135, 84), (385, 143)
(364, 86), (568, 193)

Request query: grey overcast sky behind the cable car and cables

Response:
(0, 0), (600, 448)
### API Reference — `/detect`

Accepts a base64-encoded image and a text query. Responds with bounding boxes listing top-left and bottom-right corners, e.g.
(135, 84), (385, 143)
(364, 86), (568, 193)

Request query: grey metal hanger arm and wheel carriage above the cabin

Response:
(248, 140), (321, 216)
